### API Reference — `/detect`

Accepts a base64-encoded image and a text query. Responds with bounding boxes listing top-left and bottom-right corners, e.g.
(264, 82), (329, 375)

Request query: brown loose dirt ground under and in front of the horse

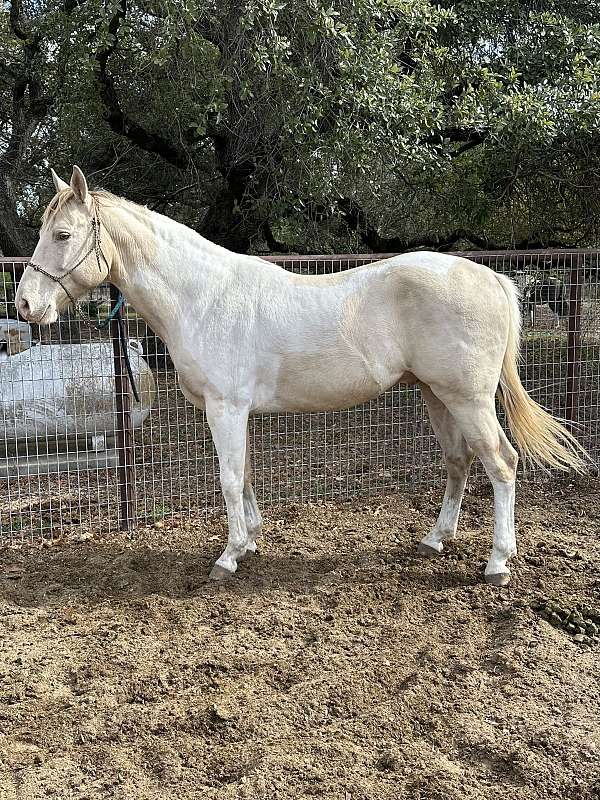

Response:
(0, 479), (600, 800)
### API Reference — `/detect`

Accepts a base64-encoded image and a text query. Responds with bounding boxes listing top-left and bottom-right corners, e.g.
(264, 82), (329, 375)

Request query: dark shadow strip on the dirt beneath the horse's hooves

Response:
(0, 540), (482, 607)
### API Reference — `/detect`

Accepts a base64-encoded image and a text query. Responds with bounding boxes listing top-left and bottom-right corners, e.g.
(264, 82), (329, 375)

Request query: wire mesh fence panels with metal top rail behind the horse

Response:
(0, 250), (600, 541)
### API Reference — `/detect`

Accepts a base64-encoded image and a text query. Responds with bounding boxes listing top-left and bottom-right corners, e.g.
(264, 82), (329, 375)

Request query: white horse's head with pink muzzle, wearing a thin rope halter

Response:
(15, 166), (112, 325)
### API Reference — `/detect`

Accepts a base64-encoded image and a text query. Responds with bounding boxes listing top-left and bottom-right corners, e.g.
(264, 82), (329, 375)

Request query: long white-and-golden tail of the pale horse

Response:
(496, 274), (591, 473)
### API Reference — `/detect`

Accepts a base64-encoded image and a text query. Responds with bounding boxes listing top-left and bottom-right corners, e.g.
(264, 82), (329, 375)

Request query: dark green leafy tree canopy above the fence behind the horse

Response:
(0, 0), (600, 255)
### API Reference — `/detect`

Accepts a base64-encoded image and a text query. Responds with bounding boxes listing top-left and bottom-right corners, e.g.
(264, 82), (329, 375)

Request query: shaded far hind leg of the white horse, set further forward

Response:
(418, 384), (474, 555)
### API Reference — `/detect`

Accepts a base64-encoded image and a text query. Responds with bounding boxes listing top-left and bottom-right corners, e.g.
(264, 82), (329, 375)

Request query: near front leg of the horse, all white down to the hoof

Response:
(206, 398), (248, 580)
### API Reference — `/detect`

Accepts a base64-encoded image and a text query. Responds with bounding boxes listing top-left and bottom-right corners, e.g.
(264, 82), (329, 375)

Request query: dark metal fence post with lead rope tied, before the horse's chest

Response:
(110, 284), (135, 531)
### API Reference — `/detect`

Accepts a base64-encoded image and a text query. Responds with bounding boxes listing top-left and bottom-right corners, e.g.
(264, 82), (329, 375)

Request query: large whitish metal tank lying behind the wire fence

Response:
(0, 320), (156, 479)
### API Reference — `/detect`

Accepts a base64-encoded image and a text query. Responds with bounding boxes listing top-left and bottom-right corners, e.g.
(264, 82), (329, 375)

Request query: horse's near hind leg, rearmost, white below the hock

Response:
(432, 392), (519, 586)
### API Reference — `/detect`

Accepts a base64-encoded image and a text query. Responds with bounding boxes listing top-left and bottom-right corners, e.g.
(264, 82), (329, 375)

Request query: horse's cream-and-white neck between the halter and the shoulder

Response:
(107, 206), (239, 343)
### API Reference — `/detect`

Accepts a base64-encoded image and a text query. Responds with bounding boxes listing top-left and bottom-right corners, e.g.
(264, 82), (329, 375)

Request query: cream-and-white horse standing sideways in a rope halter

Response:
(15, 167), (586, 586)
